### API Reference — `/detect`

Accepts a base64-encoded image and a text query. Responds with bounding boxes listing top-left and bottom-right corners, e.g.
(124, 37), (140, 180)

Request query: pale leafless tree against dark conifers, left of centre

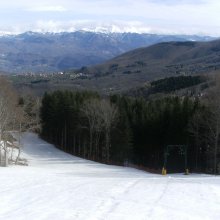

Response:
(82, 99), (117, 163)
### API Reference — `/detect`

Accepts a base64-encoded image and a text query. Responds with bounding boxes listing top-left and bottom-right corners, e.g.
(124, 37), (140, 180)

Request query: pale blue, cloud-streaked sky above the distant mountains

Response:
(0, 0), (220, 36)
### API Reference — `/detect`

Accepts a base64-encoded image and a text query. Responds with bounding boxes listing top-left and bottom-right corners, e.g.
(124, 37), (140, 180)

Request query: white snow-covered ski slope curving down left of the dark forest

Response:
(0, 133), (220, 220)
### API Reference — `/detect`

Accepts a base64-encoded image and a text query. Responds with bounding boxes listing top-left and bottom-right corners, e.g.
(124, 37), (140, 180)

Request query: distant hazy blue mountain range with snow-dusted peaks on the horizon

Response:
(0, 31), (213, 73)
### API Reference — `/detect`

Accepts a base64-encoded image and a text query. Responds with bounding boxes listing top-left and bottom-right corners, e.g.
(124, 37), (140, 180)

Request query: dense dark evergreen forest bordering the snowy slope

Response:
(40, 81), (219, 173)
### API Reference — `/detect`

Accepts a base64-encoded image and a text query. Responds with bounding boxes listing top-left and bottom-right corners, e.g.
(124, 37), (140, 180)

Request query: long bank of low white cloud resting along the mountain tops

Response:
(0, 20), (217, 36)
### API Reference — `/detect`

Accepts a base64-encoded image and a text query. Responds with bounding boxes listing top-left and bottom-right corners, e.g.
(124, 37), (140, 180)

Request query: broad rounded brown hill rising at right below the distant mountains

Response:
(68, 40), (220, 89)
